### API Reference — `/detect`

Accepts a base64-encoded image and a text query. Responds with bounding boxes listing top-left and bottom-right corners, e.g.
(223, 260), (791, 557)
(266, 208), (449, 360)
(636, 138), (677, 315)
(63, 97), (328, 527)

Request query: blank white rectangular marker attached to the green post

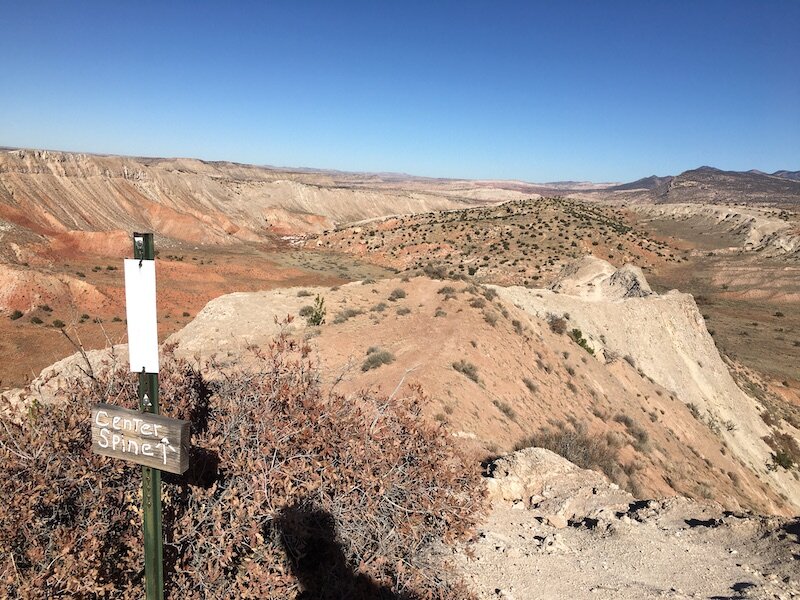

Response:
(125, 258), (158, 373)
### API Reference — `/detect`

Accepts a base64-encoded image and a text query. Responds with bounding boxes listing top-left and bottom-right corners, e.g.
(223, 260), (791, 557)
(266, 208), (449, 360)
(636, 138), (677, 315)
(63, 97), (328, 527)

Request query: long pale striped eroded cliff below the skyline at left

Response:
(0, 150), (481, 244)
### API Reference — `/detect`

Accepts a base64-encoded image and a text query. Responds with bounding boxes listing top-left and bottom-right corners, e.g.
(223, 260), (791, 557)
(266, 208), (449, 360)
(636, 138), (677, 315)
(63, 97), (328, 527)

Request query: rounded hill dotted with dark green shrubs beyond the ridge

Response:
(309, 198), (667, 286)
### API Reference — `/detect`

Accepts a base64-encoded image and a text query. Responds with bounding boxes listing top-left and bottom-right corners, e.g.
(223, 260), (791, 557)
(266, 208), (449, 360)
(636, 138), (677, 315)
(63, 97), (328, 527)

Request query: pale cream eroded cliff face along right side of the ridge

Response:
(493, 257), (800, 508)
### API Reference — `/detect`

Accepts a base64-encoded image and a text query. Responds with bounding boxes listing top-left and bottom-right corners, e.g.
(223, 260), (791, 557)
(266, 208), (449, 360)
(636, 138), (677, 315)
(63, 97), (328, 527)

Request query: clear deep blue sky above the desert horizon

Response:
(0, 0), (800, 181)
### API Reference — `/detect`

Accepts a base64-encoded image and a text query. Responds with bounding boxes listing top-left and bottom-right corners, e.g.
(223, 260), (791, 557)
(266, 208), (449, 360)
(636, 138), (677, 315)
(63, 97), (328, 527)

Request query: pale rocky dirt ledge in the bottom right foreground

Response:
(457, 448), (800, 600)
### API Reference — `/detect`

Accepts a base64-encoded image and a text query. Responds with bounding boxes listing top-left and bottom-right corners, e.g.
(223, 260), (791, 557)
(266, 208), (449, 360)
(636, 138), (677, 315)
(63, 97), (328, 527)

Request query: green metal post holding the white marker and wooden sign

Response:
(133, 233), (164, 600)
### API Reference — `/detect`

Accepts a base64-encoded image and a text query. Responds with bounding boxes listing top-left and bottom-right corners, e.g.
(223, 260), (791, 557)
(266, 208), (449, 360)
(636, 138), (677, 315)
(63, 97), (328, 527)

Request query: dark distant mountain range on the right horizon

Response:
(607, 167), (800, 205)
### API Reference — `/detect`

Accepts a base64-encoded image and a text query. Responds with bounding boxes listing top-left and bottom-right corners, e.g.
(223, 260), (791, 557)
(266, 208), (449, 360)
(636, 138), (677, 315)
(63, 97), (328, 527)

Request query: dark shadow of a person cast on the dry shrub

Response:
(274, 504), (414, 600)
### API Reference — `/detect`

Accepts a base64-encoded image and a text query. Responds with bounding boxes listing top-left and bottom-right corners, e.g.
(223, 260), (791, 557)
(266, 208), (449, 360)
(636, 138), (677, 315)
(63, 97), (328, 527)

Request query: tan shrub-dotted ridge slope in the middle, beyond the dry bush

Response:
(15, 277), (790, 512)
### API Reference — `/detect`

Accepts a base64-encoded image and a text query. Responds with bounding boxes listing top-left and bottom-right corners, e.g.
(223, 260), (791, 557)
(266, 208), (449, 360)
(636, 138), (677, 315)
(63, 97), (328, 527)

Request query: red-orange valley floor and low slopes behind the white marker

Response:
(0, 244), (391, 390)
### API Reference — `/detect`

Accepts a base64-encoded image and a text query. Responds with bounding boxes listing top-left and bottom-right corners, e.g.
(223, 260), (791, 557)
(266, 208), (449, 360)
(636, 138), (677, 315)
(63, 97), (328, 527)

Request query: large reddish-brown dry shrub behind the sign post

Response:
(0, 336), (484, 599)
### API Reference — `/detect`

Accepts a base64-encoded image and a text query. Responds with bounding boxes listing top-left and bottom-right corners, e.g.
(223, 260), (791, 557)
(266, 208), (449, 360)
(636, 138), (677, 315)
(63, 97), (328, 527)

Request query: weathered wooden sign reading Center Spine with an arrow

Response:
(92, 404), (191, 475)
